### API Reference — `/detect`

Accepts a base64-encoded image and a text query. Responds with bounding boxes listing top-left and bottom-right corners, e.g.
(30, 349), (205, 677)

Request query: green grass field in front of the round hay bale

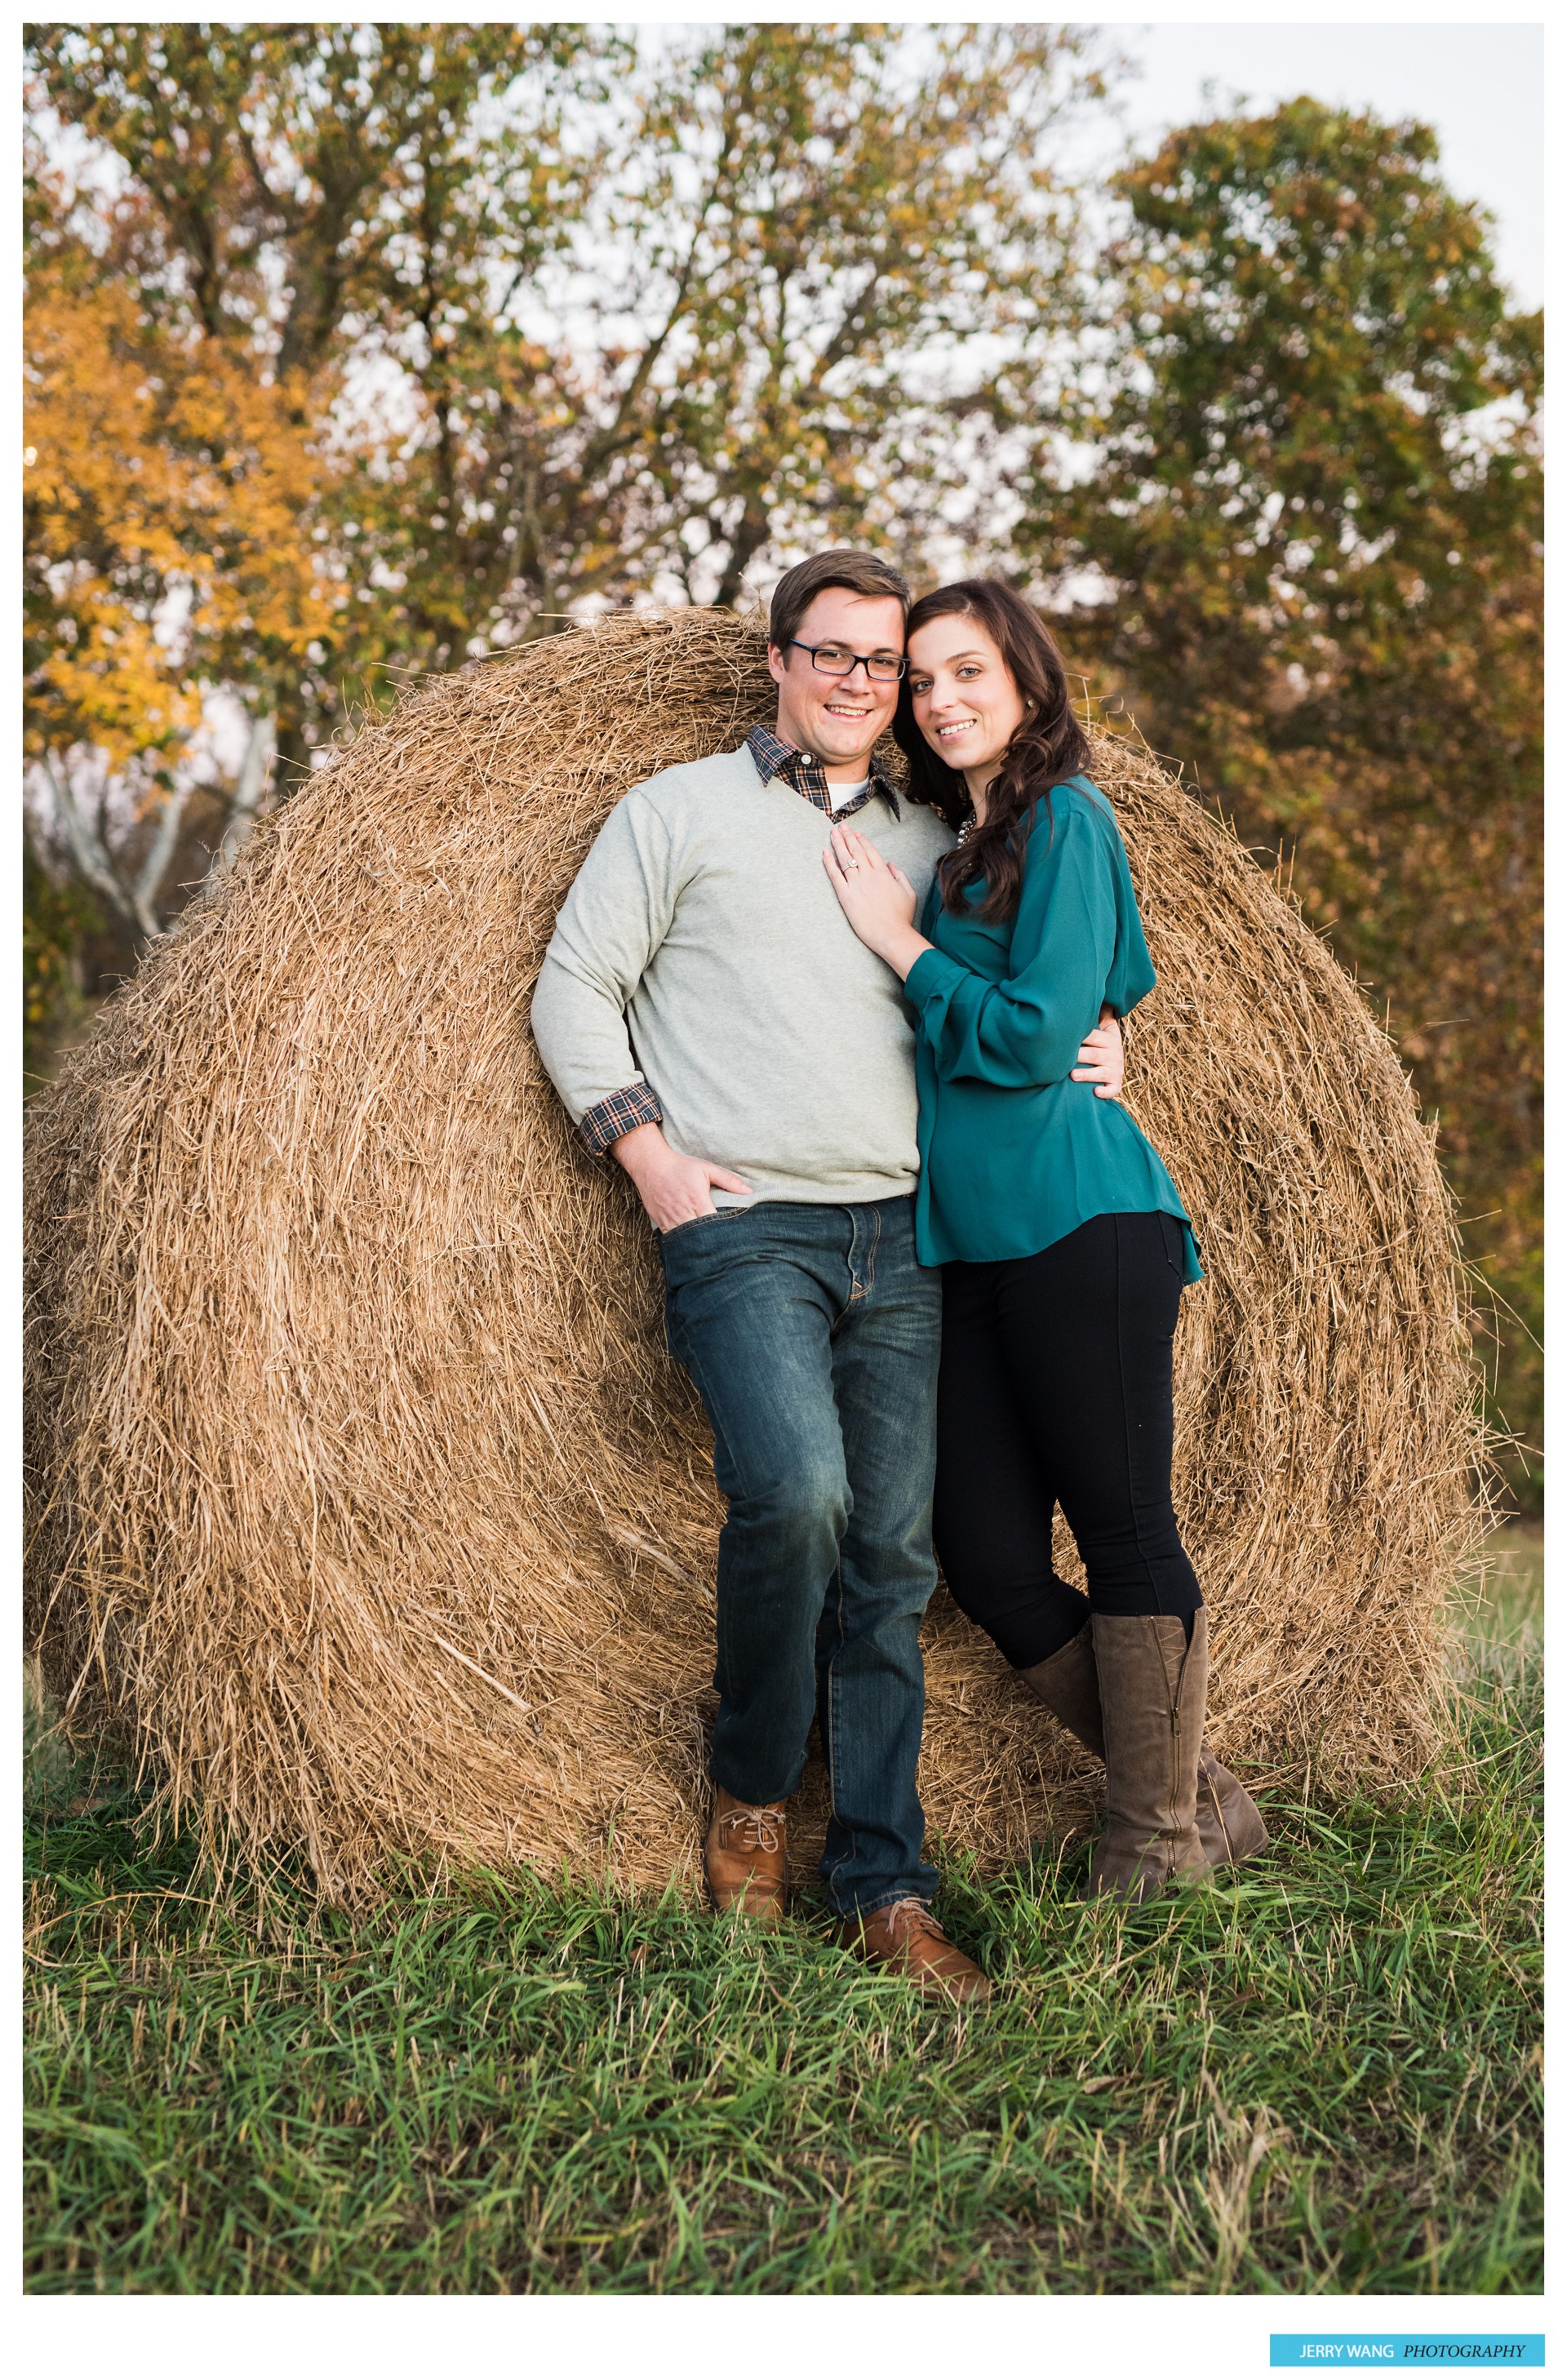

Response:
(26, 1533), (1541, 2292)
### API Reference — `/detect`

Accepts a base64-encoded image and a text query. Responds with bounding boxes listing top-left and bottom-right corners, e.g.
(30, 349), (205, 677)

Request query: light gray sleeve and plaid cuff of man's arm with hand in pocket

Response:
(529, 788), (674, 1148)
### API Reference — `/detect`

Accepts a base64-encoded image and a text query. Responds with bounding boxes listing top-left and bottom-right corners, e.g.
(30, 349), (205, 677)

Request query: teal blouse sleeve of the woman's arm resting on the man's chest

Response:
(905, 802), (1117, 1090)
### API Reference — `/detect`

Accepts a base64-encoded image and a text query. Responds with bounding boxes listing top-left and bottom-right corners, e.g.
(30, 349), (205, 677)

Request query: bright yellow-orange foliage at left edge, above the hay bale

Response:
(24, 278), (334, 762)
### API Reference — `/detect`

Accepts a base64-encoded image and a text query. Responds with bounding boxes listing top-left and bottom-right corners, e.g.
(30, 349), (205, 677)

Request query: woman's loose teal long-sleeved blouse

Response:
(905, 776), (1203, 1281)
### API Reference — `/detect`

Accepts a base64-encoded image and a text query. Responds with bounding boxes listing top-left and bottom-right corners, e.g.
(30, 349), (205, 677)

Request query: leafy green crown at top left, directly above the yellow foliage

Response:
(29, 24), (612, 376)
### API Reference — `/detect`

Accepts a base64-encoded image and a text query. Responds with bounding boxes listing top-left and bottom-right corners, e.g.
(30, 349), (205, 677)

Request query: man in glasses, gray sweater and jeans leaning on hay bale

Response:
(534, 550), (1119, 1999)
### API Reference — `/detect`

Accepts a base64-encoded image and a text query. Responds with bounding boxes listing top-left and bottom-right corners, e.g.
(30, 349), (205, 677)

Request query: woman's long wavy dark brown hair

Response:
(893, 579), (1088, 921)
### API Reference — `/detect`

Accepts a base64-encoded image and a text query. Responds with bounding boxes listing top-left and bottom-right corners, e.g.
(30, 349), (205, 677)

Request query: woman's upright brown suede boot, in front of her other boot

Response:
(1088, 1611), (1207, 1902)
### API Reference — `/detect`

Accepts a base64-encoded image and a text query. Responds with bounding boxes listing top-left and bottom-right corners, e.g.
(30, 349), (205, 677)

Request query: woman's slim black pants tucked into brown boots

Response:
(936, 1214), (1203, 1668)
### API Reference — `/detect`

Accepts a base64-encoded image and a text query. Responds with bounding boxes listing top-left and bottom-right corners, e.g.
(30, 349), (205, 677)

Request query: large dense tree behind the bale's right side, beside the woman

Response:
(1022, 100), (1541, 1494)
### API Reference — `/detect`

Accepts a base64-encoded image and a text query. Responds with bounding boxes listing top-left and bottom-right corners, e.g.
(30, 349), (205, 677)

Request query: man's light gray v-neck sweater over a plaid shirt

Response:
(534, 745), (952, 1206)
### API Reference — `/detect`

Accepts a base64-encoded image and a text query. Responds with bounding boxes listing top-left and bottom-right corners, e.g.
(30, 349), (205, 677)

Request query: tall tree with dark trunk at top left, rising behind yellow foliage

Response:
(29, 24), (602, 776)
